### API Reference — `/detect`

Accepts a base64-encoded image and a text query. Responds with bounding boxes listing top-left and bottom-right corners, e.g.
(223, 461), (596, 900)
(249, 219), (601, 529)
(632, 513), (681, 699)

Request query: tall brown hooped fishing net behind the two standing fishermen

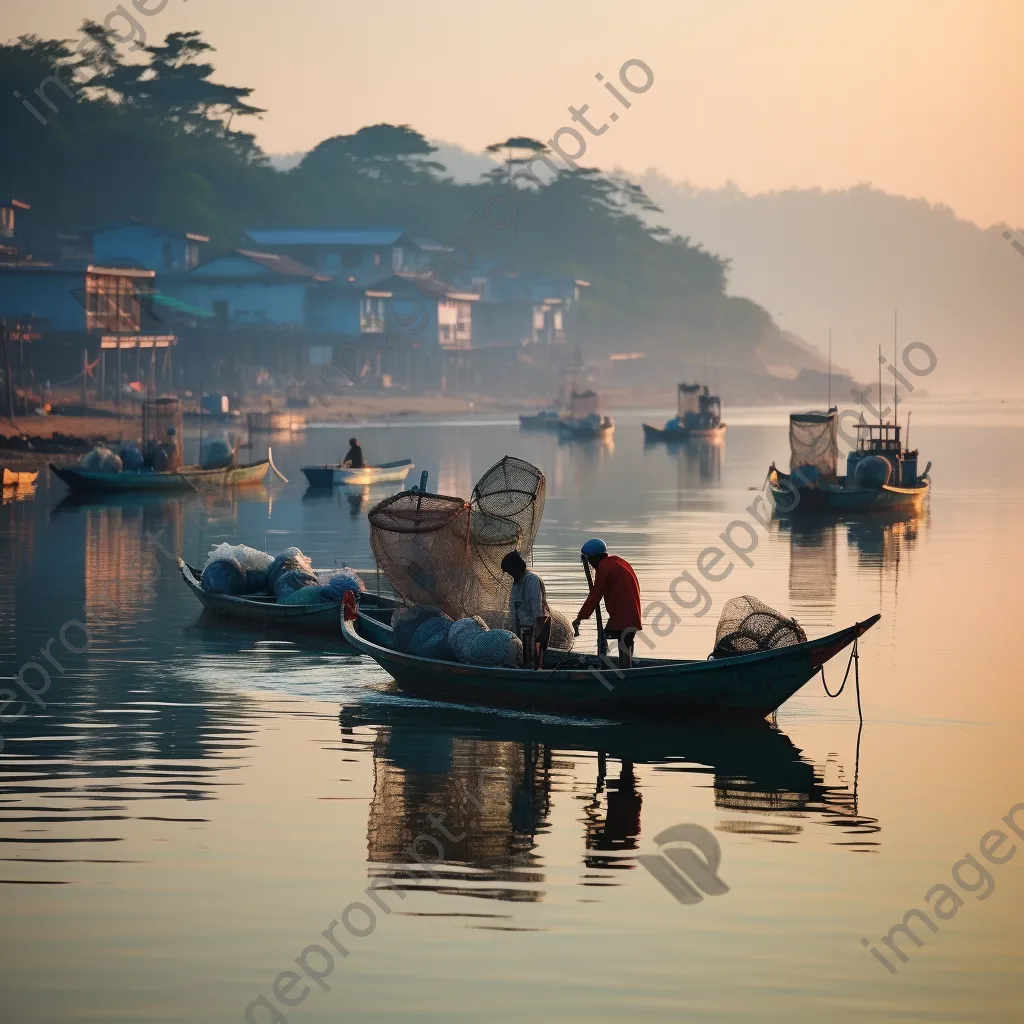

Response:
(369, 456), (545, 618)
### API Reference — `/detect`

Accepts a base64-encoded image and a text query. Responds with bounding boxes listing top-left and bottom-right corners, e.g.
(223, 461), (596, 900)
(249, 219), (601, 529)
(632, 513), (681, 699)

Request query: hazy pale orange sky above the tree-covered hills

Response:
(4, 0), (1024, 226)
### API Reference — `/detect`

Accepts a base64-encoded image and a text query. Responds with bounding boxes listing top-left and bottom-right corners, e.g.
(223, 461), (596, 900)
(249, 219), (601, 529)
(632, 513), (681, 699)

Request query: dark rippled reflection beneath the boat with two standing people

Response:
(340, 697), (880, 901)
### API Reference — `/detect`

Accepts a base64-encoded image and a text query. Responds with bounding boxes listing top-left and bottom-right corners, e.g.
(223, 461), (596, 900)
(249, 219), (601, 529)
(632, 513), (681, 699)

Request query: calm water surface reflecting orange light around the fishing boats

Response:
(0, 408), (1024, 1024)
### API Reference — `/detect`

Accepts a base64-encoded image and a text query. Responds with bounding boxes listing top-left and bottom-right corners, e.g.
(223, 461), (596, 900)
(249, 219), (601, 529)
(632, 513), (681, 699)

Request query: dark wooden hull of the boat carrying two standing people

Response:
(341, 614), (881, 718)
